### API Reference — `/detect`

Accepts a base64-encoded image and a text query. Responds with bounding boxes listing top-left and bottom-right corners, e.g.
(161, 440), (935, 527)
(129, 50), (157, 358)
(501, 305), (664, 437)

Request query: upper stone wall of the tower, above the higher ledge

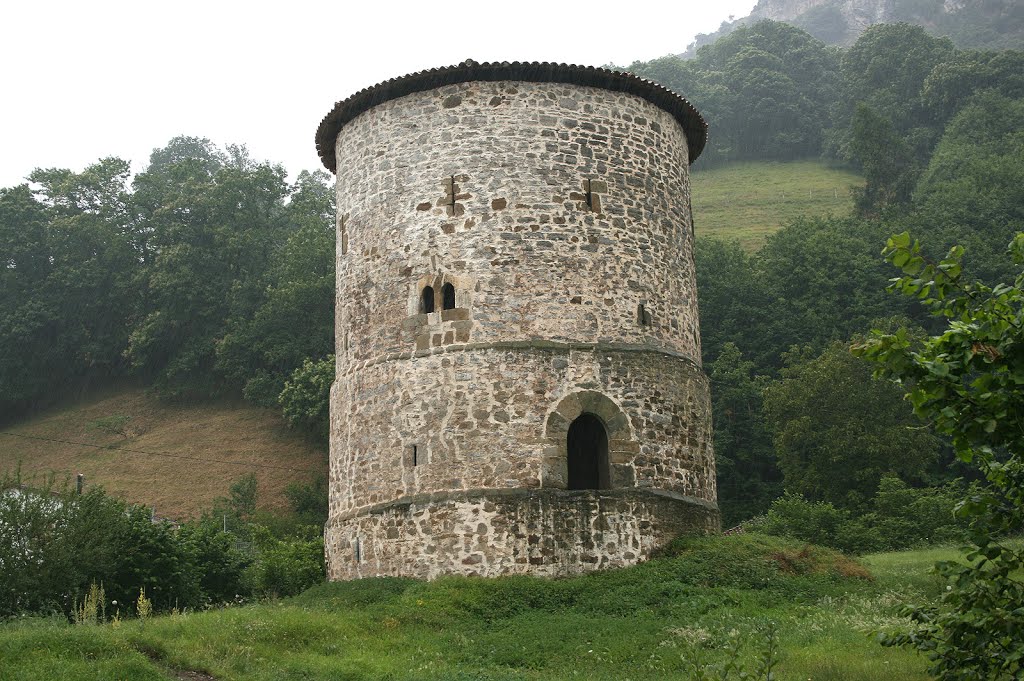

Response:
(336, 82), (700, 375)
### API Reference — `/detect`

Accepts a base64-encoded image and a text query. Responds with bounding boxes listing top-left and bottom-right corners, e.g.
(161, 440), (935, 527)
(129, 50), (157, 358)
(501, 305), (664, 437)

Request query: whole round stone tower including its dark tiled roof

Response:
(316, 61), (719, 580)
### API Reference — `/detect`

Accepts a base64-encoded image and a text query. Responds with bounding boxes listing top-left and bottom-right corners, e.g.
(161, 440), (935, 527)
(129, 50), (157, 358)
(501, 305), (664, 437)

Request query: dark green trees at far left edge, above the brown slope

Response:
(0, 159), (140, 414)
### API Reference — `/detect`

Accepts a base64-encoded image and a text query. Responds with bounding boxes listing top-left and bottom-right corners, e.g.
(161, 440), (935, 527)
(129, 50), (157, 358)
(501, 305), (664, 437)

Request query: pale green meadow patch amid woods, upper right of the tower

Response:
(690, 161), (863, 250)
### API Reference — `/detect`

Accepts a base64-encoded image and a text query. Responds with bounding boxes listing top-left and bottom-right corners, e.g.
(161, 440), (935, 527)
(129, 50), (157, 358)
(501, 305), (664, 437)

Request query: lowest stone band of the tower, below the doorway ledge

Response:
(325, 487), (720, 580)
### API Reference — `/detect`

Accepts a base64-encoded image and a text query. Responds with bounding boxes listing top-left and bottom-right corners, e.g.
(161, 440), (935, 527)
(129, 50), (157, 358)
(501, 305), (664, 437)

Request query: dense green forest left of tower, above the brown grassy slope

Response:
(0, 142), (334, 438)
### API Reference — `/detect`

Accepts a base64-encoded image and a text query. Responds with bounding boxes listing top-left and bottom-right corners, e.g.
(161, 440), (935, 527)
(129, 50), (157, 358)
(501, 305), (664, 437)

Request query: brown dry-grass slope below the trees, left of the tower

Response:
(0, 388), (327, 518)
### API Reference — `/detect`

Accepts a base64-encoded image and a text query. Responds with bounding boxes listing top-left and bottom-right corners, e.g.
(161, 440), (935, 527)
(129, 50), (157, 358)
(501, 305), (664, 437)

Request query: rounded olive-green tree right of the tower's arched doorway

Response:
(764, 343), (942, 508)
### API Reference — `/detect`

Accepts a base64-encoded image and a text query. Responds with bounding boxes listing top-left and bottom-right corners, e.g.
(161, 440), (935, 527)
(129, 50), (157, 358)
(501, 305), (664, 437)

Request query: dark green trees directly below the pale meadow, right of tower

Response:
(694, 217), (915, 376)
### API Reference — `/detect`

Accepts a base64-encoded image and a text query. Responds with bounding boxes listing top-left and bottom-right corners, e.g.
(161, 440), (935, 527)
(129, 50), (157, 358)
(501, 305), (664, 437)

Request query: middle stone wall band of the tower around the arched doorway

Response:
(331, 346), (716, 515)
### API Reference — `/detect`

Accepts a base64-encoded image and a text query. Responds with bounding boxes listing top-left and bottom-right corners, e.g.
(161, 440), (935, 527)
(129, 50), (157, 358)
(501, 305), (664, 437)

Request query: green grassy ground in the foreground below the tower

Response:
(0, 535), (955, 681)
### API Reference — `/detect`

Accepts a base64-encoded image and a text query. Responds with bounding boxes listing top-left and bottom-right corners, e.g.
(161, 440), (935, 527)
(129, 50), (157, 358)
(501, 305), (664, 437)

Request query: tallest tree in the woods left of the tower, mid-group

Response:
(127, 140), (289, 396)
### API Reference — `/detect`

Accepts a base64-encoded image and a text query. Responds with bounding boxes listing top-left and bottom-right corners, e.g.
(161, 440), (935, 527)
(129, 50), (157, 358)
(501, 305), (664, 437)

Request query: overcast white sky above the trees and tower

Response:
(0, 0), (756, 186)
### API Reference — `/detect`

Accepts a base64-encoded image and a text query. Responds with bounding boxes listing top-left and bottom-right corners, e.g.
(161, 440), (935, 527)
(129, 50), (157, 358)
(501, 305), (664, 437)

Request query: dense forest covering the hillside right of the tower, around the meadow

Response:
(614, 22), (1024, 522)
